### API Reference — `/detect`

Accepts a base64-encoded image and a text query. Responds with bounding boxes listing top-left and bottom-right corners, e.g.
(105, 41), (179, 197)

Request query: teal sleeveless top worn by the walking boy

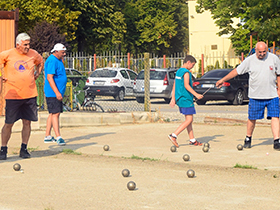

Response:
(175, 68), (194, 107)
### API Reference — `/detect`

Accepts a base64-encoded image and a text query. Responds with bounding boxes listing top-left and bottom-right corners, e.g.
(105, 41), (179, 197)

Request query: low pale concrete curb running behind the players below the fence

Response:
(0, 111), (270, 132)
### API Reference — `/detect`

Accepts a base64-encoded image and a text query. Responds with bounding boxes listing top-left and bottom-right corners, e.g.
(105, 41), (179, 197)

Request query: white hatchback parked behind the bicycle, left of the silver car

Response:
(86, 67), (137, 101)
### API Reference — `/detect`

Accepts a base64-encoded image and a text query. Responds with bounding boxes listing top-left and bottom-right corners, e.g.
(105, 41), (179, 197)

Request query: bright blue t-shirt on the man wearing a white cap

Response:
(44, 55), (67, 97)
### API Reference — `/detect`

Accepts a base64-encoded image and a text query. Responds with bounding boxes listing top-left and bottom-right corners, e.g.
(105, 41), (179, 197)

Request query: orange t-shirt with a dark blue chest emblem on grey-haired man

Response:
(0, 48), (43, 99)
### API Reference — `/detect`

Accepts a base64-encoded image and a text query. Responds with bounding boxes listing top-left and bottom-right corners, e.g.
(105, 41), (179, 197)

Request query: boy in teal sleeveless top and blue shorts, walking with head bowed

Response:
(168, 55), (203, 147)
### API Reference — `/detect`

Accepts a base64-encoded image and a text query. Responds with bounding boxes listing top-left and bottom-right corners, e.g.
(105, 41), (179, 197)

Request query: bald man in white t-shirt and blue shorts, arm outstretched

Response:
(216, 42), (280, 150)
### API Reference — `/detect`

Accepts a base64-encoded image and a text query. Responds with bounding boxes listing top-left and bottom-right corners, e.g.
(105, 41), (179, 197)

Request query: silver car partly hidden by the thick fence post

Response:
(133, 68), (177, 103)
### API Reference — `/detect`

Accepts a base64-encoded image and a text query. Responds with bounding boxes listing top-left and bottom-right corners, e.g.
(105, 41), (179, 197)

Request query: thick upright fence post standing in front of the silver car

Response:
(144, 53), (150, 112)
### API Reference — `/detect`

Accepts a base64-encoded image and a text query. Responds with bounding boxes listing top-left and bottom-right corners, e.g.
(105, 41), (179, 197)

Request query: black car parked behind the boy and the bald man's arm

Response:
(193, 69), (249, 105)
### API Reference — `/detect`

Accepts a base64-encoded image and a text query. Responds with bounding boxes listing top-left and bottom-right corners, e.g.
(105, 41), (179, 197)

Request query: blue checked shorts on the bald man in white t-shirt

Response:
(248, 97), (279, 120)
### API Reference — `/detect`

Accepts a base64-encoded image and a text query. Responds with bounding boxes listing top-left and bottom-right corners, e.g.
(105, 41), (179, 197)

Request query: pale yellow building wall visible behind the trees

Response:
(188, 0), (240, 75)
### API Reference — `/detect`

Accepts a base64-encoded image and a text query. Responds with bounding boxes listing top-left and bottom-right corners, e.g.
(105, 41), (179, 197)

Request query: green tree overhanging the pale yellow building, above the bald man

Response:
(196, 0), (280, 53)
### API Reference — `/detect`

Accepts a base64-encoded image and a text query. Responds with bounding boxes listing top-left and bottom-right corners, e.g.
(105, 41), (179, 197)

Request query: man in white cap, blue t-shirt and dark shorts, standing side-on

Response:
(44, 43), (67, 146)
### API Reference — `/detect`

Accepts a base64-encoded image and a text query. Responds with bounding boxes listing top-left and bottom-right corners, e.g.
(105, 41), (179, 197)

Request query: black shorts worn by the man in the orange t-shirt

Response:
(5, 97), (38, 124)
